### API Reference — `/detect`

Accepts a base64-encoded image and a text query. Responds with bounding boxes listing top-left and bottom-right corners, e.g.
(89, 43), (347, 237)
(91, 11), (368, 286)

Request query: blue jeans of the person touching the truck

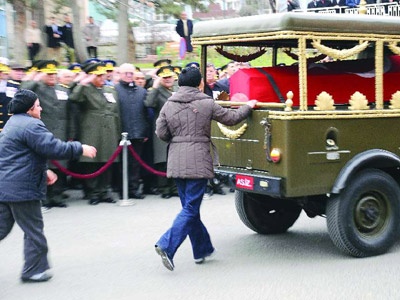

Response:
(157, 178), (214, 259)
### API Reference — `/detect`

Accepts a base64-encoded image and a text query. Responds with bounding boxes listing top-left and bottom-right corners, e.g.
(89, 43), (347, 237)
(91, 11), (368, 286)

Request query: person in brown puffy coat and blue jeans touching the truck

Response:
(155, 67), (256, 271)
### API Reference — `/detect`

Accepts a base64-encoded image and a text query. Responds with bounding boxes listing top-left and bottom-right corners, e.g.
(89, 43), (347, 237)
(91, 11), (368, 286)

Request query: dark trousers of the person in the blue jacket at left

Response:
(0, 200), (50, 278)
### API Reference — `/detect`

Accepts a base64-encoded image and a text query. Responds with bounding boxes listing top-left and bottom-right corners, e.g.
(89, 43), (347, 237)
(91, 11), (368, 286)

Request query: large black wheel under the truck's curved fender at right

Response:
(326, 169), (400, 257)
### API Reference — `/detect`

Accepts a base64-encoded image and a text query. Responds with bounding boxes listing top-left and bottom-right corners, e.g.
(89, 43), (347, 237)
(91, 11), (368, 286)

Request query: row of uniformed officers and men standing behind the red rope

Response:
(0, 58), (248, 211)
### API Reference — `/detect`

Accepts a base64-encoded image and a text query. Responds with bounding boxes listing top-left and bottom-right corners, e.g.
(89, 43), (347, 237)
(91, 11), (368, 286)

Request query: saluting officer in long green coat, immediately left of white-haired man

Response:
(70, 62), (121, 205)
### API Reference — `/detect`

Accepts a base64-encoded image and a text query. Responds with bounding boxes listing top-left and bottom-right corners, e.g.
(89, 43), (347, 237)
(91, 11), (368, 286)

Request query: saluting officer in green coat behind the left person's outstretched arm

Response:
(22, 60), (71, 208)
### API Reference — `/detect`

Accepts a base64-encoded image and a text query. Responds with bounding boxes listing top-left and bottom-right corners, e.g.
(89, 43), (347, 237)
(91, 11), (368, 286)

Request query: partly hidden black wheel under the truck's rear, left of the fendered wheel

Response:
(235, 191), (301, 234)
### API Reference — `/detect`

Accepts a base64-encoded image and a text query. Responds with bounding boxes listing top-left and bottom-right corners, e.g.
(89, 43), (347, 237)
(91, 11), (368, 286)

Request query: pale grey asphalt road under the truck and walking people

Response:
(0, 191), (400, 300)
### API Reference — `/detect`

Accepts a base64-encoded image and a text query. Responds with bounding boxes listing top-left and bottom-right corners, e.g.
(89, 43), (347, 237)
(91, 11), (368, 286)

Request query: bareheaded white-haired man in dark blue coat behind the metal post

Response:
(115, 63), (149, 199)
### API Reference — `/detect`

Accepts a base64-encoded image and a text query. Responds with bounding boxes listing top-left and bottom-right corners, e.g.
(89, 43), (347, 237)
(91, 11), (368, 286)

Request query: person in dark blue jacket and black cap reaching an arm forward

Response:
(0, 89), (96, 282)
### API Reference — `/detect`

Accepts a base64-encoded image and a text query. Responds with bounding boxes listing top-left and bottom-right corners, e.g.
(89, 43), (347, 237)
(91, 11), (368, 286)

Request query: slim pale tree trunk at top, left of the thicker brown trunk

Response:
(71, 0), (89, 63)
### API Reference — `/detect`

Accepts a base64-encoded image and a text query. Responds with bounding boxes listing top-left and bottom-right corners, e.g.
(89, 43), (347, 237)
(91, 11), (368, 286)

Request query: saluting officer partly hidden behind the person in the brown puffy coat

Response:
(145, 66), (178, 198)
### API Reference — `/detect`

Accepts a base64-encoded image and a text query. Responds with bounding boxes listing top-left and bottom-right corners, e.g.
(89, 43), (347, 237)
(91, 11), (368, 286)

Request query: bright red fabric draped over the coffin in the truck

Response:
(230, 56), (400, 106)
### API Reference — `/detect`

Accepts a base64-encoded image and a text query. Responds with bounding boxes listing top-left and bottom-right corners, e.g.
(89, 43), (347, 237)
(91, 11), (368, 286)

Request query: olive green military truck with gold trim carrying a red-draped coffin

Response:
(193, 12), (400, 257)
